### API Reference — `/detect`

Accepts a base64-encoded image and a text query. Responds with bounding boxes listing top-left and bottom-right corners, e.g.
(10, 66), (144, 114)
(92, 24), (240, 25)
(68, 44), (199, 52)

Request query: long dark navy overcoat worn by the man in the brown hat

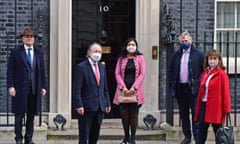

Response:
(7, 45), (46, 114)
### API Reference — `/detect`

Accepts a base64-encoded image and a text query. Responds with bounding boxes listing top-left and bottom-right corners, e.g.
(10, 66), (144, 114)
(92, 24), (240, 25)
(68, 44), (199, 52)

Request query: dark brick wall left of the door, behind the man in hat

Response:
(0, 0), (50, 112)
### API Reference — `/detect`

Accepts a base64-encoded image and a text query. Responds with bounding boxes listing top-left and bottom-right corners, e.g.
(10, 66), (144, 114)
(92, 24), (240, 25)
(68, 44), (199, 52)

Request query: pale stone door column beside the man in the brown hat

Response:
(48, 0), (72, 128)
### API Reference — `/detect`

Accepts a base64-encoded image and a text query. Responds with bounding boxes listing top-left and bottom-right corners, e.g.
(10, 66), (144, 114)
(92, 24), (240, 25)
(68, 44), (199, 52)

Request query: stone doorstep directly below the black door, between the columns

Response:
(47, 119), (166, 140)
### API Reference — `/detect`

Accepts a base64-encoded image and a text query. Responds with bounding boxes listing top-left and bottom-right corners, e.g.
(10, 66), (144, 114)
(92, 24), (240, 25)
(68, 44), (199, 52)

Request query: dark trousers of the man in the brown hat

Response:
(15, 92), (36, 142)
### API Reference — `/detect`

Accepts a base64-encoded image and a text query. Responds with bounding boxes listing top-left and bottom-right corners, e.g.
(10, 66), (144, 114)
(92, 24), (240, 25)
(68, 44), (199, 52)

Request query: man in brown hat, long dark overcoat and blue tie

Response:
(7, 28), (46, 144)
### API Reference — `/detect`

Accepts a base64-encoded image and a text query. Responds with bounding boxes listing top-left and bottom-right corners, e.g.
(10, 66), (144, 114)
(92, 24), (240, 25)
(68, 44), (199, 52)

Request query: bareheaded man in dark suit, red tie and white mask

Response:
(73, 43), (111, 144)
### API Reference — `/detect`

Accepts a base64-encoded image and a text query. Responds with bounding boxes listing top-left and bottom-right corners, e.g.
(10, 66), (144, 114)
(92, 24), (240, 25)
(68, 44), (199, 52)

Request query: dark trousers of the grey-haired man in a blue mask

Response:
(177, 84), (198, 141)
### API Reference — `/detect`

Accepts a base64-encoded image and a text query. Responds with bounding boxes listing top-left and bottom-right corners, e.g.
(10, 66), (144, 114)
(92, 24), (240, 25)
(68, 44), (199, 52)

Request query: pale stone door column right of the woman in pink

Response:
(136, 0), (160, 127)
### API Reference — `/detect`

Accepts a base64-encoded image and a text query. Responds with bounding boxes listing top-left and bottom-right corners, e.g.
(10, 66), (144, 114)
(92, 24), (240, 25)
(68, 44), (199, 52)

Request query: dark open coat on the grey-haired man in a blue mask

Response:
(167, 47), (204, 97)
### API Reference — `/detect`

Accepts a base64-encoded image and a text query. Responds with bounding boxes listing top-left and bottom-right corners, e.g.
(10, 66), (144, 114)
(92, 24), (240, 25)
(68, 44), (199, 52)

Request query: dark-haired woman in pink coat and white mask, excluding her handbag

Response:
(113, 38), (146, 144)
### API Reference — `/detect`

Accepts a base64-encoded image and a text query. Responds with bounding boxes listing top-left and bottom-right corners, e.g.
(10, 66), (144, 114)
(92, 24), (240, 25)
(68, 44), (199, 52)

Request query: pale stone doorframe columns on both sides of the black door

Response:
(48, 0), (160, 128)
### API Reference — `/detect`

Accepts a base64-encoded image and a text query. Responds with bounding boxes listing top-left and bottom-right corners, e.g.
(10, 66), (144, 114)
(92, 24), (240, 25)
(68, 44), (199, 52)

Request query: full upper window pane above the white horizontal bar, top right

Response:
(217, 2), (234, 28)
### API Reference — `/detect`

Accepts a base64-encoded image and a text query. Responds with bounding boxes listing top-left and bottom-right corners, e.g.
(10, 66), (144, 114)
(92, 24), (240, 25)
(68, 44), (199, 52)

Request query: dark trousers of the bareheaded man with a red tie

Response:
(78, 110), (104, 144)
